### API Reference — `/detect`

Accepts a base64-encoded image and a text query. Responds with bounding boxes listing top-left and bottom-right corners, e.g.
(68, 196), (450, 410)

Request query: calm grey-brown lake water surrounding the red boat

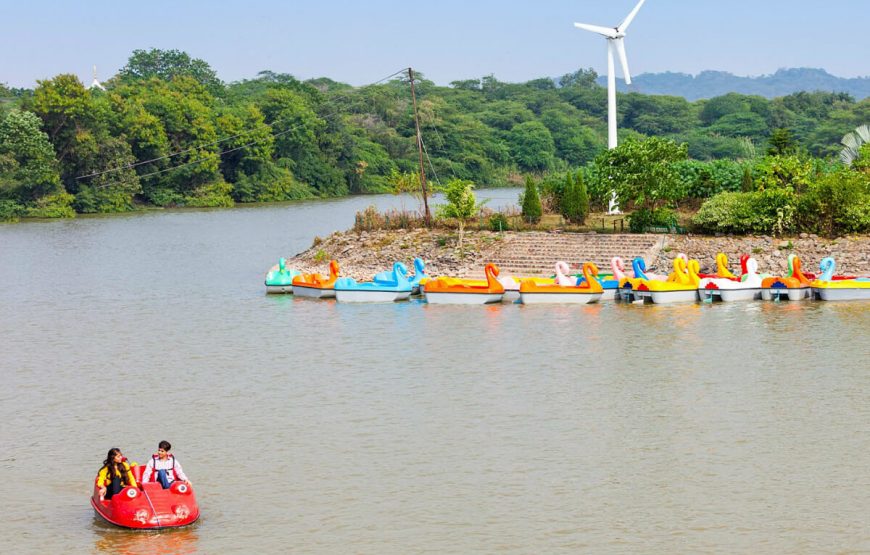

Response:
(0, 190), (870, 554)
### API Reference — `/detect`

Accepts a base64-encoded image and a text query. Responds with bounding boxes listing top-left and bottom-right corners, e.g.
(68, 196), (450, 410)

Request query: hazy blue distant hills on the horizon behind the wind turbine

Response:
(598, 68), (870, 100)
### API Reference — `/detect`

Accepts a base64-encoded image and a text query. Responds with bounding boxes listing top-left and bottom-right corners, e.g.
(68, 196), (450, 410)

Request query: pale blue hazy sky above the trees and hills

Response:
(0, 0), (870, 88)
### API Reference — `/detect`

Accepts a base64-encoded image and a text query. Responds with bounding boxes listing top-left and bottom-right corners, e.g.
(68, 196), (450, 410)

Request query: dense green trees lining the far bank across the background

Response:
(0, 50), (870, 219)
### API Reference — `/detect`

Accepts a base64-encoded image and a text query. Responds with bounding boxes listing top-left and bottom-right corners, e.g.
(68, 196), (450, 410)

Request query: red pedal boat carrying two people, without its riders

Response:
(91, 466), (199, 530)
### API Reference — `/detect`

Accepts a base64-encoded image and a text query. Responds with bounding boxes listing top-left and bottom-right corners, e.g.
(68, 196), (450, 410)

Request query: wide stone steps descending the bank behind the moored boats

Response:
(487, 232), (665, 276)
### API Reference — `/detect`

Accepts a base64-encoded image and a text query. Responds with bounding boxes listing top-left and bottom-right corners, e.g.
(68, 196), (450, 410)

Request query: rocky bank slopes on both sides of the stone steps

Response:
(287, 229), (870, 281)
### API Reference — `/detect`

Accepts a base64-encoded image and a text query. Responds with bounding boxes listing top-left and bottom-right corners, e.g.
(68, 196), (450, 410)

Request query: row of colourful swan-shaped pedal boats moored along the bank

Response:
(265, 253), (870, 304)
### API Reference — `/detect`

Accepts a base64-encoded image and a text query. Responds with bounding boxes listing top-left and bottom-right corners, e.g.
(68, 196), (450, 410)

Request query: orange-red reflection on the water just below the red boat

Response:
(93, 515), (199, 555)
